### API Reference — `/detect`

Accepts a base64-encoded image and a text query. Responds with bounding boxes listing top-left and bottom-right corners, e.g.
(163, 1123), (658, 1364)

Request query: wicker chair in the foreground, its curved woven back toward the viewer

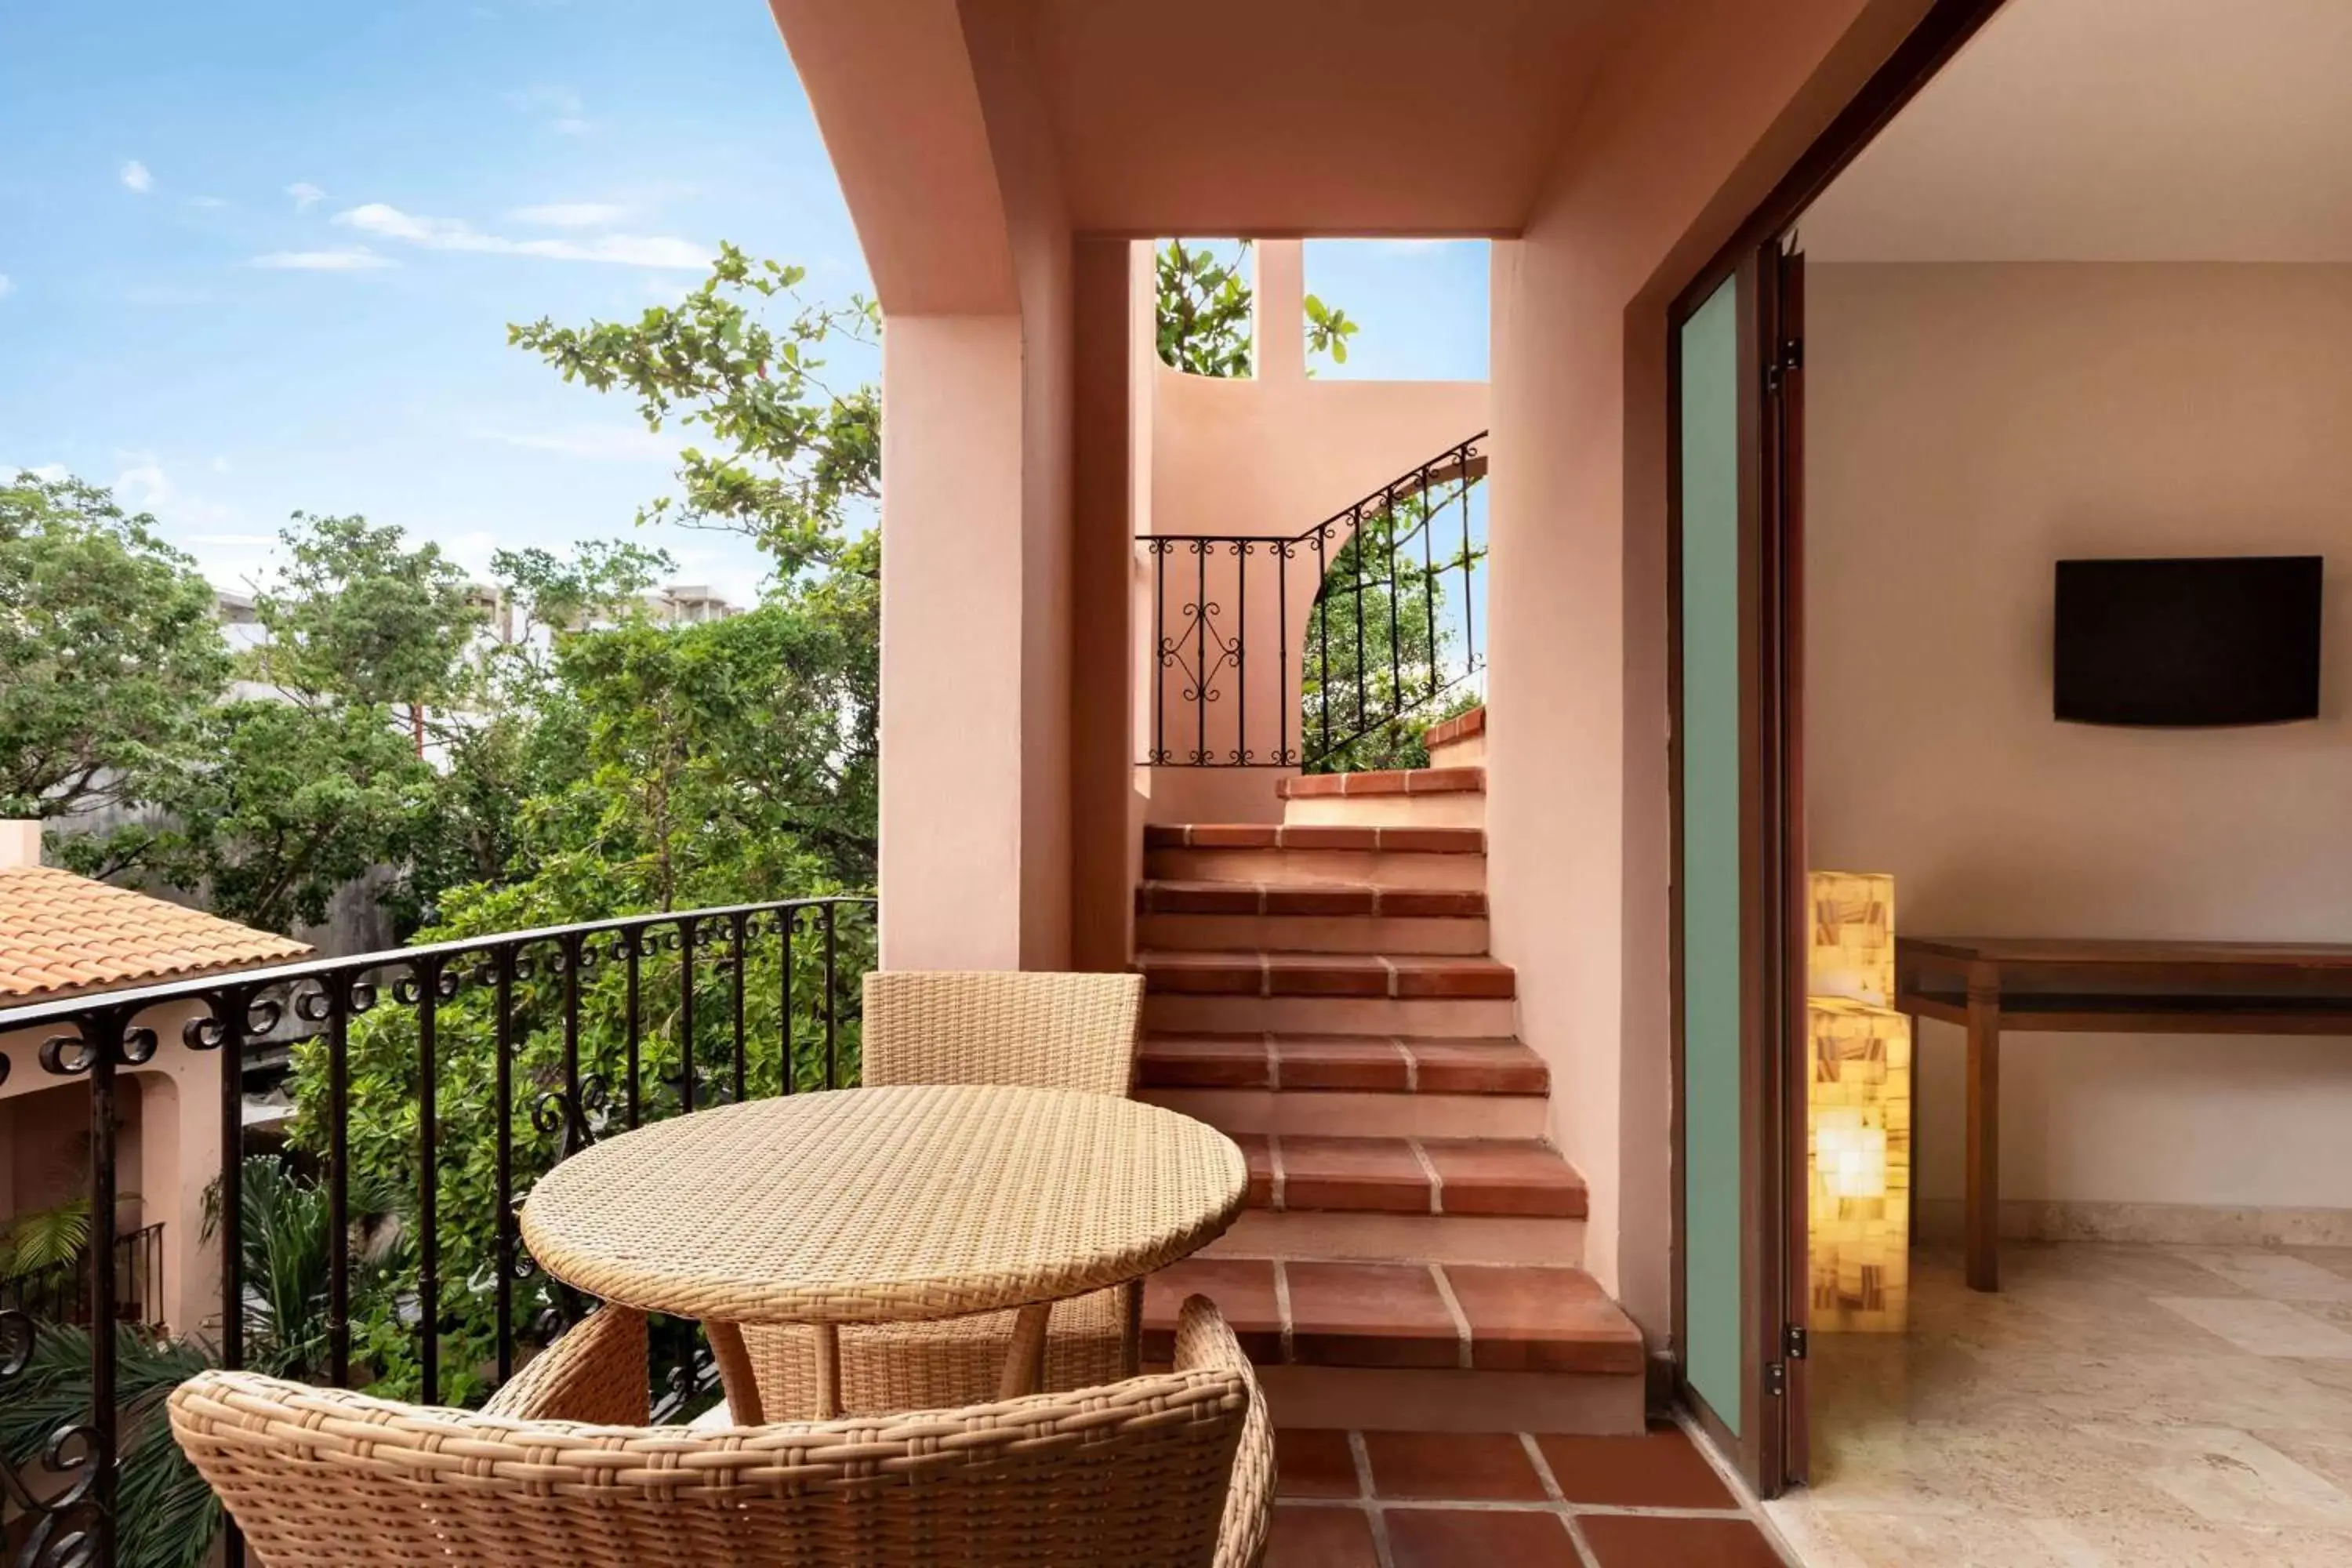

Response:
(172, 1298), (1272, 1568)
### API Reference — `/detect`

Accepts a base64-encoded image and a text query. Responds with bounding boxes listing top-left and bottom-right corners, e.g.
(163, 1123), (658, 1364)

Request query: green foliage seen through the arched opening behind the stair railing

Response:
(1301, 494), (1484, 774)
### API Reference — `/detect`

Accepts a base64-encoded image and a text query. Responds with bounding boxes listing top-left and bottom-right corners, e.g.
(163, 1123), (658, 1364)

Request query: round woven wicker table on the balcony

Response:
(522, 1086), (1249, 1425)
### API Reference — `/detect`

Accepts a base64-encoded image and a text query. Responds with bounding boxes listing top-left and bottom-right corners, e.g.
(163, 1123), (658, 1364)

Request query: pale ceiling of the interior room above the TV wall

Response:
(1799, 0), (2352, 261)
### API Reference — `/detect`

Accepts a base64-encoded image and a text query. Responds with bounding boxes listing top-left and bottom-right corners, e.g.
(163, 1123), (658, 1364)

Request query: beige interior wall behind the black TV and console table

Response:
(1806, 263), (2352, 1206)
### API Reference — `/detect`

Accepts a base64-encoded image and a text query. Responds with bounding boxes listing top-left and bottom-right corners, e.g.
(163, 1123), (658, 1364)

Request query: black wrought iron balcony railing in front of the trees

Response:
(0, 898), (873, 1568)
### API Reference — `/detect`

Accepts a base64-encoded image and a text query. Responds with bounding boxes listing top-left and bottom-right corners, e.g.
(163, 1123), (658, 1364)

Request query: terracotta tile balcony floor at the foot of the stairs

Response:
(1265, 1427), (1780, 1568)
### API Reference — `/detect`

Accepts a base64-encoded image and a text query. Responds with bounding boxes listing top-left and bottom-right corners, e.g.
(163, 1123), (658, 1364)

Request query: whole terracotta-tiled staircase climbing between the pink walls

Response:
(1136, 713), (1644, 1432)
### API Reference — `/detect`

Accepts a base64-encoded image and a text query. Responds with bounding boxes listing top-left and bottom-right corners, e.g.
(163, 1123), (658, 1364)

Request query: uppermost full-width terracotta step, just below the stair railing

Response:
(1143, 822), (1486, 891)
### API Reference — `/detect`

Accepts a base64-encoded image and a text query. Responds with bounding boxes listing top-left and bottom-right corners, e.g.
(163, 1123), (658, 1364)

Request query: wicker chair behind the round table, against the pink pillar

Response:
(743, 971), (1143, 1420)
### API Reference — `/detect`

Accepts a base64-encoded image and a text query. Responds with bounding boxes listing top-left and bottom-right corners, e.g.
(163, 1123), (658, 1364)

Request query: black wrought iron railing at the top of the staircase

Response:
(1136, 430), (1486, 774)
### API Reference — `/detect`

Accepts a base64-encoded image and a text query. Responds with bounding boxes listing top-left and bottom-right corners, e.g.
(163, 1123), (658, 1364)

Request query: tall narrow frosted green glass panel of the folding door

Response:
(1677, 282), (1745, 1432)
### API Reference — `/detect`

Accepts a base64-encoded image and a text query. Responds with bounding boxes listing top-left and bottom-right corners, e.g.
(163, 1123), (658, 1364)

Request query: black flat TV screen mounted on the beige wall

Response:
(2053, 555), (2319, 727)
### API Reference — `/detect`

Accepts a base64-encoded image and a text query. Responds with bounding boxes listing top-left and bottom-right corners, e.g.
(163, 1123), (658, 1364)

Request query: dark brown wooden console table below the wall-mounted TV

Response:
(1896, 935), (2352, 1290)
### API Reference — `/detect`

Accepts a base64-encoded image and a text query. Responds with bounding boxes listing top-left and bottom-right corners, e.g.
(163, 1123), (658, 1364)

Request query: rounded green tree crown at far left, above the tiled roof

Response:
(0, 473), (228, 820)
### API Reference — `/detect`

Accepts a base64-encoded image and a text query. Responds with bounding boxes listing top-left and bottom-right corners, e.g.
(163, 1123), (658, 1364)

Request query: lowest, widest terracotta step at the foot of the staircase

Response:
(1143, 1258), (1644, 1432)
